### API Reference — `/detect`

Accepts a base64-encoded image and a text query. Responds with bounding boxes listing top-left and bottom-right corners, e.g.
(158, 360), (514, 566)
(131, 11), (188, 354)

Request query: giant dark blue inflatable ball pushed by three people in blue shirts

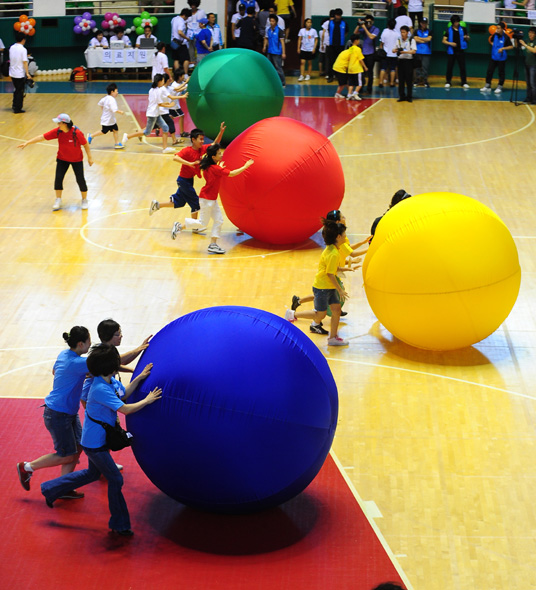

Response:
(127, 306), (338, 513)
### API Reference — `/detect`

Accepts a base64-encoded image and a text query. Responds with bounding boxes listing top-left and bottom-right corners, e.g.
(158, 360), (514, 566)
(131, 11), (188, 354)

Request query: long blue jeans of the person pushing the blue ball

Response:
(41, 447), (130, 531)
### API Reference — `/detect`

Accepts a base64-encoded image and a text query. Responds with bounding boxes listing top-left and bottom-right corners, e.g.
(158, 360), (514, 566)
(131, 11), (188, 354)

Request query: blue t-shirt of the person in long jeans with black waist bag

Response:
(81, 377), (125, 449)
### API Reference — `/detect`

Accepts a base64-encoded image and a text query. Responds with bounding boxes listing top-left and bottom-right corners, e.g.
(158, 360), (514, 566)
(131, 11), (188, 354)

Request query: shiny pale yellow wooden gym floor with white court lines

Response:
(0, 88), (536, 590)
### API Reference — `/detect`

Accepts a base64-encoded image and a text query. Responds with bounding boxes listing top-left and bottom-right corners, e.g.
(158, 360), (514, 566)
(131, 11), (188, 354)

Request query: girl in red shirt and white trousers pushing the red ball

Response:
(182, 143), (253, 254)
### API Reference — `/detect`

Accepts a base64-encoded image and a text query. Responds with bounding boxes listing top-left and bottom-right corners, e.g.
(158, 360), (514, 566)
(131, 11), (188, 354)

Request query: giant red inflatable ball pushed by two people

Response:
(220, 117), (344, 244)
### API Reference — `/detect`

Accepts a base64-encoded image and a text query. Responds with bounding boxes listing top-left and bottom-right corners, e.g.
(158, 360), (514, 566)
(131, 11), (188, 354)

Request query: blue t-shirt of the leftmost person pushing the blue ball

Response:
(45, 348), (88, 416)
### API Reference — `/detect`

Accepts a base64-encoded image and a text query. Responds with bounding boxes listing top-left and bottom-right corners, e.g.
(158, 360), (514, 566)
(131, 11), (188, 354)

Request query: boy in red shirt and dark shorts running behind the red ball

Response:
(149, 121), (225, 235)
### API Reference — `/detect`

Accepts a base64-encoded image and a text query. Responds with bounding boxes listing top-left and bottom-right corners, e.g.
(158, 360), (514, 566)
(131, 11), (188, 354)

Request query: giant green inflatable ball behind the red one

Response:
(186, 49), (284, 144)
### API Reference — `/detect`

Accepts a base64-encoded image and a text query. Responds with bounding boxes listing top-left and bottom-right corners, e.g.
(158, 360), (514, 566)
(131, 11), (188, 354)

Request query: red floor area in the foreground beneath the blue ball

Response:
(0, 399), (400, 590)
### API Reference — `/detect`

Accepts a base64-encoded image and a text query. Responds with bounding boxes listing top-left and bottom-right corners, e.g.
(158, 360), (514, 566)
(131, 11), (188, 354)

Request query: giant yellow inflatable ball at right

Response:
(363, 193), (521, 350)
